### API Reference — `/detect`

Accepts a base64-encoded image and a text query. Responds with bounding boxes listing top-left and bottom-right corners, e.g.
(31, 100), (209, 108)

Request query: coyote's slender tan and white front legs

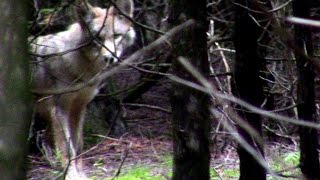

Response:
(51, 95), (86, 179)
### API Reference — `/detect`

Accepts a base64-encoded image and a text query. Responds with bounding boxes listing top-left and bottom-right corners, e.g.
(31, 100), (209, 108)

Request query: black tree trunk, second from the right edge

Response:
(232, 0), (268, 180)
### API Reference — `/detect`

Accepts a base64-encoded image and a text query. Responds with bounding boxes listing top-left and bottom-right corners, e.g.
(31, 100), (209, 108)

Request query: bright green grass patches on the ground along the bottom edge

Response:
(91, 152), (300, 180)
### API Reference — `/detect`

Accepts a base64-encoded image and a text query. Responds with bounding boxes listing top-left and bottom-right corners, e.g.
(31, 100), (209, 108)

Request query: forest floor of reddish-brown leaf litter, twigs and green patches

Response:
(28, 77), (299, 180)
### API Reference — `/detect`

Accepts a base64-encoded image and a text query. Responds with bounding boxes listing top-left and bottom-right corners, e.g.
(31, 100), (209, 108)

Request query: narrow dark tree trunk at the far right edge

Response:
(293, 0), (320, 180)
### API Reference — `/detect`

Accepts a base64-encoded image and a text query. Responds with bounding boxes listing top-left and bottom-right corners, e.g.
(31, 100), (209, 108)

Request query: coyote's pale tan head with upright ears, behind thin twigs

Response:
(82, 0), (135, 63)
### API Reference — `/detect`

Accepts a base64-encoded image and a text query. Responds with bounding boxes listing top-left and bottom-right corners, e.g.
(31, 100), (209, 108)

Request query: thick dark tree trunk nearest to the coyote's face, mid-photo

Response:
(168, 0), (210, 180)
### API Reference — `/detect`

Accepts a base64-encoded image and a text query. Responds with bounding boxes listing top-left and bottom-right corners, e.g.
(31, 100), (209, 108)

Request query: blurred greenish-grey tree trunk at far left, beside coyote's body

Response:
(0, 0), (31, 180)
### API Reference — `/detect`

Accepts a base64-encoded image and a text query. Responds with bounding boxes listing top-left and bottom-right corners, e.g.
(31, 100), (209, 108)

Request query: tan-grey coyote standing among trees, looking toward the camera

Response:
(31, 0), (135, 179)
